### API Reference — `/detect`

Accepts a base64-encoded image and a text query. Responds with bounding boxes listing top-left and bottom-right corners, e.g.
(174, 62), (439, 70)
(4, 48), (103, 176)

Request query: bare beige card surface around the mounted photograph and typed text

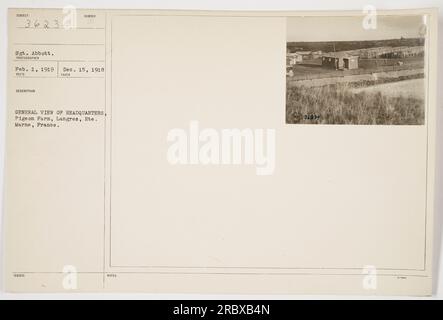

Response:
(5, 9), (437, 295)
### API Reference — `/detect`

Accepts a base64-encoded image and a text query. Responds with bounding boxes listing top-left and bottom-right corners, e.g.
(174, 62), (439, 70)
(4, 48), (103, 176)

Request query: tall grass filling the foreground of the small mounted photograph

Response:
(286, 83), (424, 125)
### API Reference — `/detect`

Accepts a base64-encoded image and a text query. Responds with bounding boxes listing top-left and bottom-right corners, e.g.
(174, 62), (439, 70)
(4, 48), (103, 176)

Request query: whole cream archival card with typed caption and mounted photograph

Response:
(4, 7), (437, 295)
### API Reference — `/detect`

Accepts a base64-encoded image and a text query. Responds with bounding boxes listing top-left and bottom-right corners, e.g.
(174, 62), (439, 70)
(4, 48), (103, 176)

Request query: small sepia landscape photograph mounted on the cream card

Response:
(286, 15), (426, 125)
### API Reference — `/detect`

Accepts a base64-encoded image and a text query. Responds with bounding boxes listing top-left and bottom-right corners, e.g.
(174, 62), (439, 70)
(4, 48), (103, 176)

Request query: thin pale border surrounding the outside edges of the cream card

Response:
(0, 0), (443, 300)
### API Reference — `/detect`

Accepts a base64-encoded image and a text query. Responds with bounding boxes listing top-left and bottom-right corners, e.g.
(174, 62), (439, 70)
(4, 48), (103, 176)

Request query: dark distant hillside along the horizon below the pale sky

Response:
(287, 38), (425, 52)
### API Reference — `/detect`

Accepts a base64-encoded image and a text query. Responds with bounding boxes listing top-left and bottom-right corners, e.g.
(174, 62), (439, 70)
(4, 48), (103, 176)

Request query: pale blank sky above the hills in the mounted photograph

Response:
(286, 15), (423, 42)
